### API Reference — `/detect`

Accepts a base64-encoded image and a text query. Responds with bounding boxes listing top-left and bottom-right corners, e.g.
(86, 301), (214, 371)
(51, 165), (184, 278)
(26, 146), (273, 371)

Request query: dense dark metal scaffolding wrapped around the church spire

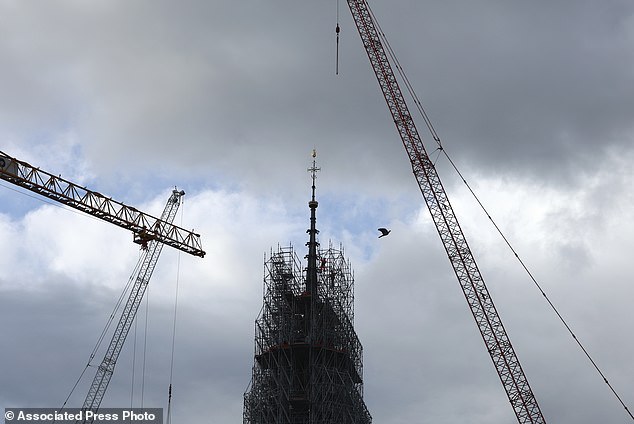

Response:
(243, 242), (372, 424)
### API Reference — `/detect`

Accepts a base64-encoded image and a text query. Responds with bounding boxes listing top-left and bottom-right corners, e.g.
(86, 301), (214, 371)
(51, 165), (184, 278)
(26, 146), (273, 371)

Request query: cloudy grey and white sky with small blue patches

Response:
(0, 0), (634, 424)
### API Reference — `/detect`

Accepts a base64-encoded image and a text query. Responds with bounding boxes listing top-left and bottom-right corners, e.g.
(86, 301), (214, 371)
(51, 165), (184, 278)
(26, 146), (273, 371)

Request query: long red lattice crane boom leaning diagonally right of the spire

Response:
(347, 0), (546, 424)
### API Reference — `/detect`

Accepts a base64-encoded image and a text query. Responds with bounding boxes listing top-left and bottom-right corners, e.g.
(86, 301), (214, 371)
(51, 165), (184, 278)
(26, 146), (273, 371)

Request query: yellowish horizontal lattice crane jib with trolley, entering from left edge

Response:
(0, 151), (205, 257)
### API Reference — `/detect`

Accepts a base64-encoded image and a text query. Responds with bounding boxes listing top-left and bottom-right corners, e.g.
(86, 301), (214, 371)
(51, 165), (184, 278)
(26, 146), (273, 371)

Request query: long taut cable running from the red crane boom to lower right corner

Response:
(368, 4), (634, 420)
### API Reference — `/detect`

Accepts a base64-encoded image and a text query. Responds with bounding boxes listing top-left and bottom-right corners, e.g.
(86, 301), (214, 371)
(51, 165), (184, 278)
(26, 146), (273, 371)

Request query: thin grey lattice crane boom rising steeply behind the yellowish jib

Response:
(82, 190), (185, 423)
